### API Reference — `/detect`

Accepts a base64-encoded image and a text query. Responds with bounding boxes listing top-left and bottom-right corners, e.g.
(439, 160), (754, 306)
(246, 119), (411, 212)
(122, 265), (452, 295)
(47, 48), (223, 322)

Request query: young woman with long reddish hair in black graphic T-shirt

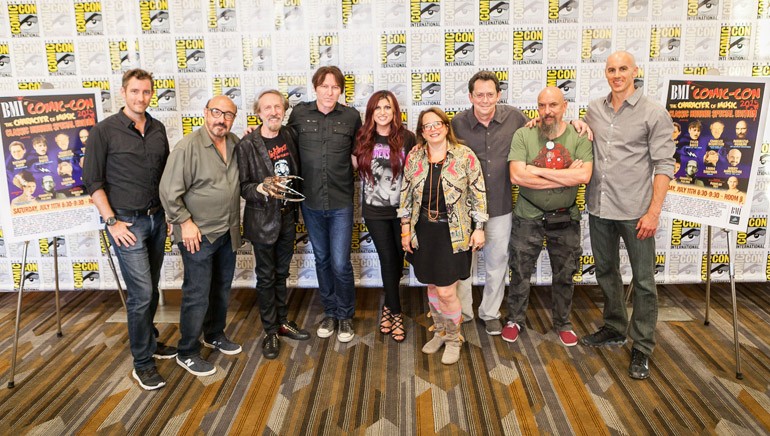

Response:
(355, 91), (415, 342)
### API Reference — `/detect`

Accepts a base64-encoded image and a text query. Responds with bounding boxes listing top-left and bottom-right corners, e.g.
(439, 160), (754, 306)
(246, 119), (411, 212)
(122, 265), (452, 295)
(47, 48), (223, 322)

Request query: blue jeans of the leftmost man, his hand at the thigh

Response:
(107, 210), (166, 369)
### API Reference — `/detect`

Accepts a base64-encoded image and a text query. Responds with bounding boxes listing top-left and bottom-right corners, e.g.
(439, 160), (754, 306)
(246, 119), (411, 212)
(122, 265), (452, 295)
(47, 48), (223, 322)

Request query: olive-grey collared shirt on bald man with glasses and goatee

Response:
(160, 127), (241, 251)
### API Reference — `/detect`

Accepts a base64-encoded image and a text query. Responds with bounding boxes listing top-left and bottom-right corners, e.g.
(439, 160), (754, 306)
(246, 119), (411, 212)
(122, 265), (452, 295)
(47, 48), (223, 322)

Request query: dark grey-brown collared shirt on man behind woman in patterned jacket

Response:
(452, 104), (527, 217)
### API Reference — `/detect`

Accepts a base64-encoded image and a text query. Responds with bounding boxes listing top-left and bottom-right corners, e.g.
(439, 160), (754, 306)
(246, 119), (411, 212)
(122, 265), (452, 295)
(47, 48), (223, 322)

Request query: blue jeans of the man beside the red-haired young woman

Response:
(302, 204), (356, 319)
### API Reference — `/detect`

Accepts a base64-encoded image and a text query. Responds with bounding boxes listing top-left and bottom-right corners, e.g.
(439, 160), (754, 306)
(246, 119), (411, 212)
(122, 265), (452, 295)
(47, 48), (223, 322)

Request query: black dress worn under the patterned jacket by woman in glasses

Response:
(406, 162), (473, 286)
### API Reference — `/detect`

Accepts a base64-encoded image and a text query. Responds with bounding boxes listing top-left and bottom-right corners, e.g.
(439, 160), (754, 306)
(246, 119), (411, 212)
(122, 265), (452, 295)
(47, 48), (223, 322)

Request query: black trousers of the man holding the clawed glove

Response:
(252, 214), (296, 334)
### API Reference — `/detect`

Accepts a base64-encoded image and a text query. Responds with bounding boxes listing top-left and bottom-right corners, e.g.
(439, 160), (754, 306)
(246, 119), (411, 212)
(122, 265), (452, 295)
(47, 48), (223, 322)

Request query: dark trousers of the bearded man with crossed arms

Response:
(508, 215), (583, 331)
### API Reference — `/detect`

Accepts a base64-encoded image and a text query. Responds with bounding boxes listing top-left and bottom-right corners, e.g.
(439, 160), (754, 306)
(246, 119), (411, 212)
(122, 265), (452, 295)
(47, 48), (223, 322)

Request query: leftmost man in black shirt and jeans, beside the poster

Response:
(83, 69), (176, 390)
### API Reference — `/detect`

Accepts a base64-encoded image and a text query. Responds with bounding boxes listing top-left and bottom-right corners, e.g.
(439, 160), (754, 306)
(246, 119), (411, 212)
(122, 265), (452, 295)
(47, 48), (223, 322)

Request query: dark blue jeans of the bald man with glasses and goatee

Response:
(177, 233), (236, 358)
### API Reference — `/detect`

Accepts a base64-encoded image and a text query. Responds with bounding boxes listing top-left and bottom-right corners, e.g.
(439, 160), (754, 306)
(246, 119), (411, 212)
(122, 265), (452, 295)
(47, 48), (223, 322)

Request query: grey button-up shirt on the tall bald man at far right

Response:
(585, 89), (675, 220)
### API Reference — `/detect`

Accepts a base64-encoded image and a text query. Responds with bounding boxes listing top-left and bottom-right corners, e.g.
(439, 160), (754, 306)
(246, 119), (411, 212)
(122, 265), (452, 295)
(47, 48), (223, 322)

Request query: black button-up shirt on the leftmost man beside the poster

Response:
(83, 108), (169, 210)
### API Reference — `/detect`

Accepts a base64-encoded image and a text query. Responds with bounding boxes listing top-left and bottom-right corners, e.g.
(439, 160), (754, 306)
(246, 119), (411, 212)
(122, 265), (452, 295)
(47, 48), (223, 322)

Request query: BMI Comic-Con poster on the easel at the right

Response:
(663, 76), (770, 232)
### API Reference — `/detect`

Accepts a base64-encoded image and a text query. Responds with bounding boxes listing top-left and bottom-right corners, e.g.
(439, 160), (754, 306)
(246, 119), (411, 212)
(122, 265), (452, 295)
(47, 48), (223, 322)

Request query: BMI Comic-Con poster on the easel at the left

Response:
(0, 89), (101, 242)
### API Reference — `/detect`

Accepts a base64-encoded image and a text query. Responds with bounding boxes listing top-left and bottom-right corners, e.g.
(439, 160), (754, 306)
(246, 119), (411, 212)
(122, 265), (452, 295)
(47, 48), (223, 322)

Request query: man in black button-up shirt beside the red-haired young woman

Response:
(288, 66), (361, 342)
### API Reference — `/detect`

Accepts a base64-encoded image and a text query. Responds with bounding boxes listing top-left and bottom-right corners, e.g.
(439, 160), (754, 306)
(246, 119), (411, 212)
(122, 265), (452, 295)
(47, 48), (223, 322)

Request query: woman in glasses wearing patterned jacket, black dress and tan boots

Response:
(398, 107), (489, 365)
